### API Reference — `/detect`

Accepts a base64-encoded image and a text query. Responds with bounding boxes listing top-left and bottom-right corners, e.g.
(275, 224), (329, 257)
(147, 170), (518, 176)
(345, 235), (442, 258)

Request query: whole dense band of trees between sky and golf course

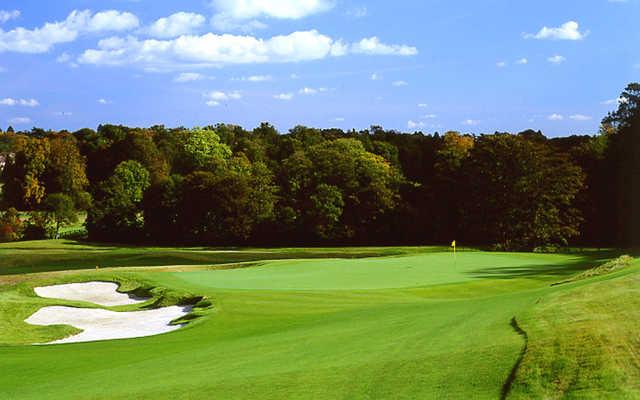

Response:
(0, 84), (640, 250)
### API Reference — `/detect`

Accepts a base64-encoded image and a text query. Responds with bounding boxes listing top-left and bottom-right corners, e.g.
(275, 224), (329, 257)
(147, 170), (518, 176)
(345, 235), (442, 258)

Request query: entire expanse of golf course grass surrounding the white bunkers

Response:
(0, 242), (640, 399)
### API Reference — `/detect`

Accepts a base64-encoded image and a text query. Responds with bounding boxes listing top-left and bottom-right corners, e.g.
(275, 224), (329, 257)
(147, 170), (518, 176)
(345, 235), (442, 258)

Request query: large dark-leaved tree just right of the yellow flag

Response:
(463, 134), (584, 250)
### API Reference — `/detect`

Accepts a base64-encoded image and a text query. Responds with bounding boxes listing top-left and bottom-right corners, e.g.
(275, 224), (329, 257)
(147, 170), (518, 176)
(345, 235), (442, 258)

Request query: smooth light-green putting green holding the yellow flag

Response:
(166, 252), (596, 290)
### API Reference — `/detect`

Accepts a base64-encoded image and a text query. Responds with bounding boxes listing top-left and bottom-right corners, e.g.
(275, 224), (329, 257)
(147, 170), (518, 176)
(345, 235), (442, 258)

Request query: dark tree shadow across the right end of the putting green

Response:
(468, 250), (625, 279)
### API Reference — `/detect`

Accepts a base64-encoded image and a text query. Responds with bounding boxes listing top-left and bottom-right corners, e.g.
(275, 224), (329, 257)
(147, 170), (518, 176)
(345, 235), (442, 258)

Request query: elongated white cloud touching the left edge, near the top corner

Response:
(0, 10), (139, 53)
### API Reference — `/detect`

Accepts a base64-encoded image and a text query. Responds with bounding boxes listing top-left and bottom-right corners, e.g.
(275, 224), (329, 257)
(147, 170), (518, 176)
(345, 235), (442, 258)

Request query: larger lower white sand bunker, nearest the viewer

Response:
(25, 306), (191, 344)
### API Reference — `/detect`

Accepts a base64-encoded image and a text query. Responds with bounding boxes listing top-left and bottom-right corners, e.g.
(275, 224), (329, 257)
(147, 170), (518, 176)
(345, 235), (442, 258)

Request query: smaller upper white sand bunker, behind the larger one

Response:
(34, 282), (147, 307)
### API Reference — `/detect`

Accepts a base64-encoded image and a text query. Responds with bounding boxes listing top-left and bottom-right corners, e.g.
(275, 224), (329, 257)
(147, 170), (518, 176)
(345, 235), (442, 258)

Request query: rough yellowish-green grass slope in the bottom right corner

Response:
(511, 262), (640, 399)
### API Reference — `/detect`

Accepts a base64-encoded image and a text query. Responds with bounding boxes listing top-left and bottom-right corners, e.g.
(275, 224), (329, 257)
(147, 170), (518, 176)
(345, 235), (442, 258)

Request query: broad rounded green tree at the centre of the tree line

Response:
(280, 139), (402, 241)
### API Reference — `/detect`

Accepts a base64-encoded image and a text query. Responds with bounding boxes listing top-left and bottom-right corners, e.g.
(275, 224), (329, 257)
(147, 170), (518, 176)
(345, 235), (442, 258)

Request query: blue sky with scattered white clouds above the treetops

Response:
(0, 0), (640, 136)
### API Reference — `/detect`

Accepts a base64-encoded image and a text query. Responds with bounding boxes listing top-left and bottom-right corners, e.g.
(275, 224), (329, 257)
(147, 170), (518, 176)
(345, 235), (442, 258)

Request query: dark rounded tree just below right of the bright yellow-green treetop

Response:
(144, 156), (275, 245)
